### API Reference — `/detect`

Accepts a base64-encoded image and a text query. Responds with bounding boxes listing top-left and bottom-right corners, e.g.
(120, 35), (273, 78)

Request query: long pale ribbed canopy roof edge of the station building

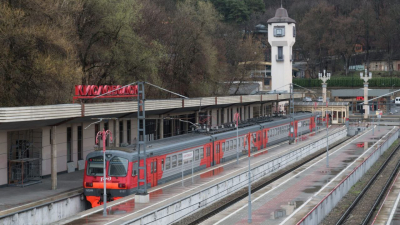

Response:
(0, 92), (302, 130)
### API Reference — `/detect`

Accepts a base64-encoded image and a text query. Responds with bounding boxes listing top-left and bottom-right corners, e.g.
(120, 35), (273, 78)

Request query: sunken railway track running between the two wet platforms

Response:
(184, 134), (350, 225)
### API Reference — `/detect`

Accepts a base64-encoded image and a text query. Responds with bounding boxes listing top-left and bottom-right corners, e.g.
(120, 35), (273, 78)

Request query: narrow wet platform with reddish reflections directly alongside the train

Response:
(55, 126), (344, 224)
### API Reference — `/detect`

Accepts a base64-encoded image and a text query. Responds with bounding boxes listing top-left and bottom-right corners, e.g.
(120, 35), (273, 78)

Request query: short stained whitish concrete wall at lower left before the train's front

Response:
(0, 194), (85, 225)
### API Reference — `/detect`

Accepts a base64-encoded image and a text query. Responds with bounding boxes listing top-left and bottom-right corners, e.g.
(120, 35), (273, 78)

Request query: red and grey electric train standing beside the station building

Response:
(83, 113), (316, 207)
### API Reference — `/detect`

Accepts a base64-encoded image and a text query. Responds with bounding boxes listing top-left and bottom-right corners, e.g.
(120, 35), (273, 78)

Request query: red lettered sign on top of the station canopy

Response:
(72, 85), (138, 101)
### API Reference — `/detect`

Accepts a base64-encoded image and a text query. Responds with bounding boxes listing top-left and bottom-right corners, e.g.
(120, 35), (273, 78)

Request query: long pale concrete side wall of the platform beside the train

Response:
(125, 129), (347, 225)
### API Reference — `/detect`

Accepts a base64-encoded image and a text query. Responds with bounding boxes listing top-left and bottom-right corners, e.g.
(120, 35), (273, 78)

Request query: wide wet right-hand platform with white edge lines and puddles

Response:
(202, 127), (398, 225)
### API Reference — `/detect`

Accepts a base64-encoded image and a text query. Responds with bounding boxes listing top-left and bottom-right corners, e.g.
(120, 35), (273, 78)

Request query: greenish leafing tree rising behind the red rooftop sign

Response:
(77, 0), (162, 84)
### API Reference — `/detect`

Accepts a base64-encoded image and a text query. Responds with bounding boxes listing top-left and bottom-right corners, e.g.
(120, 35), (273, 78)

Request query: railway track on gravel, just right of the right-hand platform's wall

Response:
(336, 143), (400, 225)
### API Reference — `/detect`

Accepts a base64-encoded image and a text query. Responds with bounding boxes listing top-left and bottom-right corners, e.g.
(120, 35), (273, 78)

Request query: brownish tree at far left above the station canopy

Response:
(0, 0), (80, 106)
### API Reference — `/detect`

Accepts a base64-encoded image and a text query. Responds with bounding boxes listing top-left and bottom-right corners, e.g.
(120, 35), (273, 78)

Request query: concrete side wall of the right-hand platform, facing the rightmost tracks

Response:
(297, 128), (399, 225)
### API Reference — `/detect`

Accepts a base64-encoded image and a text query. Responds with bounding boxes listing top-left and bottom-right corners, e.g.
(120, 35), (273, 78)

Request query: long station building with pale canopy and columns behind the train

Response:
(0, 93), (304, 187)
